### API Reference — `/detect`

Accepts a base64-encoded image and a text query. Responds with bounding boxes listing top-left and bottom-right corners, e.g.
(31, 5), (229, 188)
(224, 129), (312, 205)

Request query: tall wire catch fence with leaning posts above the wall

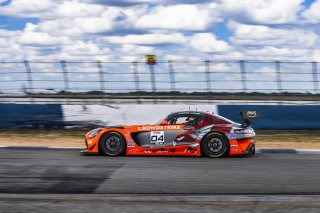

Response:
(0, 60), (319, 95)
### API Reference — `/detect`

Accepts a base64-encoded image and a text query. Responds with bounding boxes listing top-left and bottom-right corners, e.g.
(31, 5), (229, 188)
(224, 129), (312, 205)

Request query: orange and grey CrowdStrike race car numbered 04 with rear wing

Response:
(81, 111), (259, 158)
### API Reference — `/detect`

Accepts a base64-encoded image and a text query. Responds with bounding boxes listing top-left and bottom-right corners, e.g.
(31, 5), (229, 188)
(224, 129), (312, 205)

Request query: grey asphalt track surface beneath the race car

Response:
(0, 148), (320, 212)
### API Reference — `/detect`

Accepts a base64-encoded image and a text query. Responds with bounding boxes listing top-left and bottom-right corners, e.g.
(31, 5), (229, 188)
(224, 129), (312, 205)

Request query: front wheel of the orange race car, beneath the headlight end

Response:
(99, 132), (127, 156)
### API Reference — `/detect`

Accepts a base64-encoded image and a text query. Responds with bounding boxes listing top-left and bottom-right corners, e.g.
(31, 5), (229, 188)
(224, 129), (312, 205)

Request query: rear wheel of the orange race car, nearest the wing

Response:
(201, 132), (229, 158)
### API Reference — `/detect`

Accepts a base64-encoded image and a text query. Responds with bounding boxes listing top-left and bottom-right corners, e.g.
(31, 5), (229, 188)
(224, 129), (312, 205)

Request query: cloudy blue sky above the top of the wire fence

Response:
(0, 0), (320, 61)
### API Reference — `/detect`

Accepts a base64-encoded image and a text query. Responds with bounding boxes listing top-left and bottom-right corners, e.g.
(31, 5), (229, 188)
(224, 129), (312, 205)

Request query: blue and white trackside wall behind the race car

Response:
(0, 104), (320, 129)
